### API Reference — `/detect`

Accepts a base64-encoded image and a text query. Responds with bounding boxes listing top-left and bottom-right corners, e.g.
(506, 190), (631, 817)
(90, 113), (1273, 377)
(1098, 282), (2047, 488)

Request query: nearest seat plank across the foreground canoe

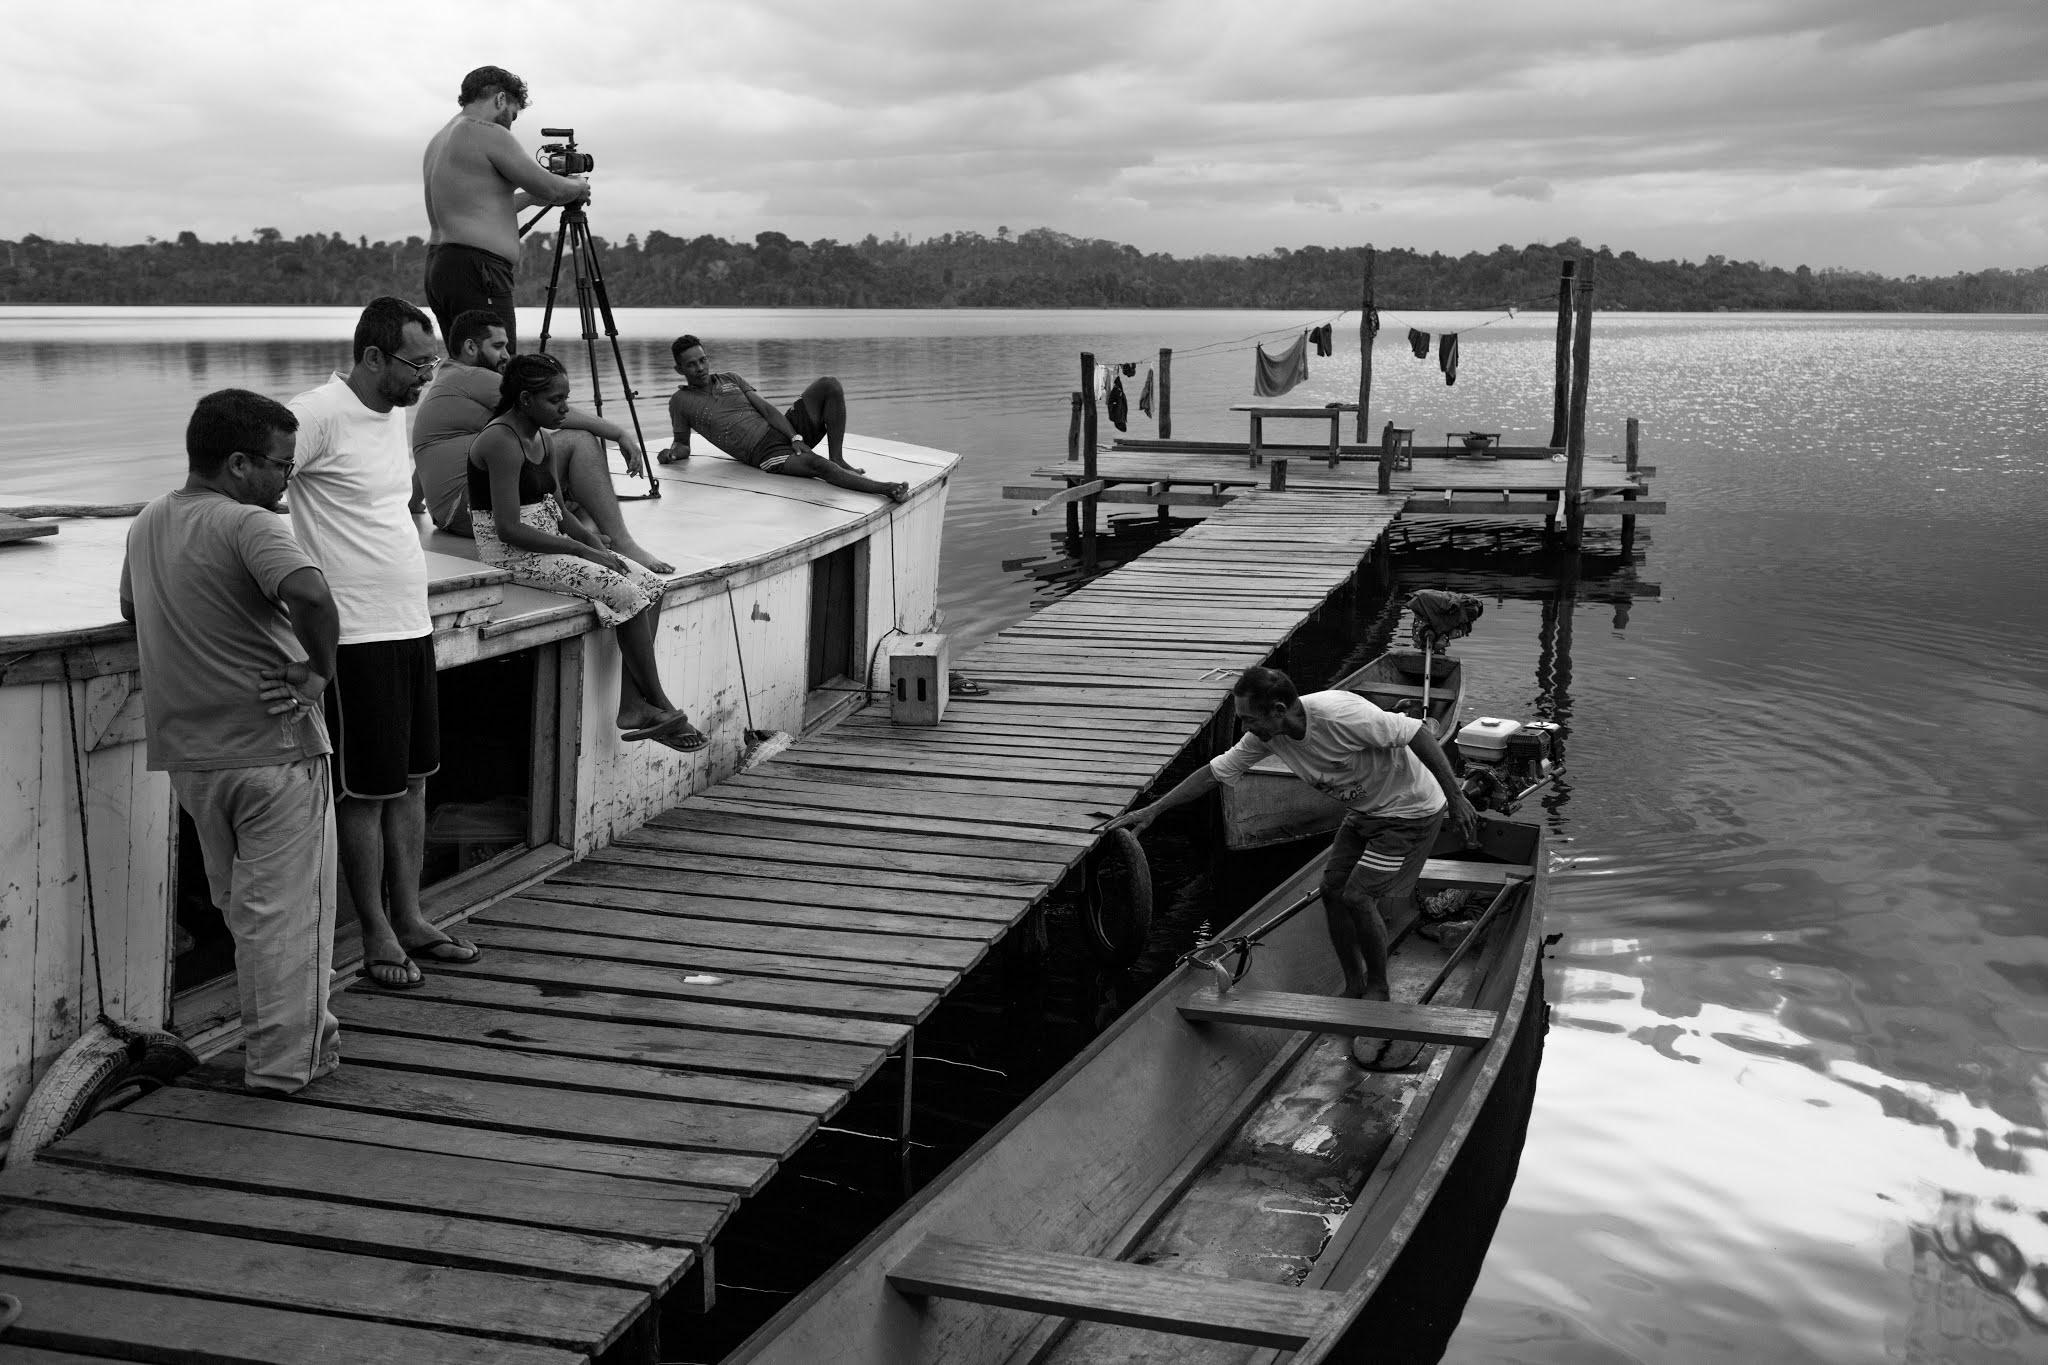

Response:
(889, 1236), (1337, 1351)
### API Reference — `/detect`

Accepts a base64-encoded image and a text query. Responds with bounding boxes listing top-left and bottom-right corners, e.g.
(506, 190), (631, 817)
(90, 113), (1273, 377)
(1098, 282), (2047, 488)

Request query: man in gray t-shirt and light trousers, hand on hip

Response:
(121, 389), (340, 1091)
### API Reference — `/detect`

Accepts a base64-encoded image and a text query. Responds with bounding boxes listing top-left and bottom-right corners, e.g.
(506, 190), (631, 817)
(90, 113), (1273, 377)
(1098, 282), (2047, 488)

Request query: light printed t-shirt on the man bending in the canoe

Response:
(1208, 692), (1444, 821)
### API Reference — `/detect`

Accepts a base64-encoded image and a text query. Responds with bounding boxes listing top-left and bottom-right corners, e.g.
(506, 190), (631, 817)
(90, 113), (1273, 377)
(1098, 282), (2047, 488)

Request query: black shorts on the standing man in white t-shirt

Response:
(328, 634), (440, 800)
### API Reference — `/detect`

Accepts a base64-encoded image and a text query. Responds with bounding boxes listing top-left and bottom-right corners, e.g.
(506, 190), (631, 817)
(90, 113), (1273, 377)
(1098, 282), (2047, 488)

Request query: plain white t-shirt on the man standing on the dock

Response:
(285, 375), (434, 645)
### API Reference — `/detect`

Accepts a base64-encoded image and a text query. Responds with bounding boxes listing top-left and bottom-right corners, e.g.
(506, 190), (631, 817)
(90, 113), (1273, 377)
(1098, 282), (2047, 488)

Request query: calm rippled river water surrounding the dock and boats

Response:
(0, 309), (2048, 1363)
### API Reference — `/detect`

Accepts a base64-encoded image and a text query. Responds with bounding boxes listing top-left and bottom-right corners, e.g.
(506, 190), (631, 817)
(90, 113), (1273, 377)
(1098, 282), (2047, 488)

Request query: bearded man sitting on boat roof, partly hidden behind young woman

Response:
(412, 309), (674, 573)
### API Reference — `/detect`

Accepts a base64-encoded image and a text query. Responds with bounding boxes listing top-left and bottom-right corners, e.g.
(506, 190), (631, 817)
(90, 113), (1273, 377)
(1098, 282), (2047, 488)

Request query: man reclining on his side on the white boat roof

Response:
(659, 336), (909, 501)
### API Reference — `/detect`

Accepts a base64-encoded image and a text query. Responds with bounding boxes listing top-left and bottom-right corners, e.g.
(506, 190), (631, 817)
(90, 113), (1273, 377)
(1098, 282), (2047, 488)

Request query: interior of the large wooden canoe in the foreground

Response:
(731, 821), (1544, 1365)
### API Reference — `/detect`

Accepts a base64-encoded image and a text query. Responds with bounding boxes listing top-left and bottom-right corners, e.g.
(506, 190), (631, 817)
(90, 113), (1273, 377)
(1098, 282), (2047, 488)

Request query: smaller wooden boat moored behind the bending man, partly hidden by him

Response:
(1221, 649), (1464, 851)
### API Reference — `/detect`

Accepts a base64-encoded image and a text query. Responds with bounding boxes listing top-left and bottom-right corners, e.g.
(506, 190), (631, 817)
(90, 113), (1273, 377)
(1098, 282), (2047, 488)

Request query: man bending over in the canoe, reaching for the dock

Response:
(1106, 667), (1479, 1066)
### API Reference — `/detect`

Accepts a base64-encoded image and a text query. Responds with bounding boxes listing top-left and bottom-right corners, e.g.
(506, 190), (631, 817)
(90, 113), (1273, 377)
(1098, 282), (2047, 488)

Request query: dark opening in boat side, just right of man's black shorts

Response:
(420, 649), (535, 886)
